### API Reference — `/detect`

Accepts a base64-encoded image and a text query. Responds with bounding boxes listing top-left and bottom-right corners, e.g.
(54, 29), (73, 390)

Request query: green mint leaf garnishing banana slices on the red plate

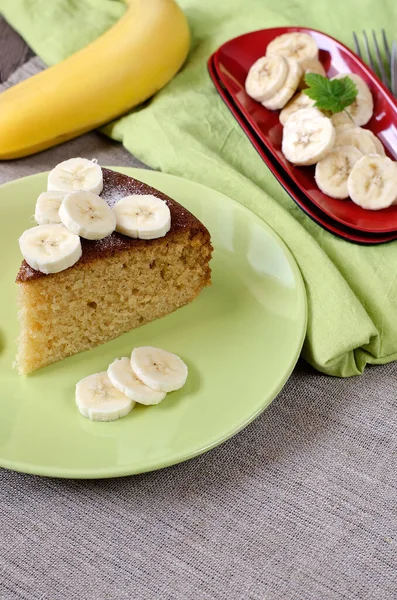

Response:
(303, 73), (358, 113)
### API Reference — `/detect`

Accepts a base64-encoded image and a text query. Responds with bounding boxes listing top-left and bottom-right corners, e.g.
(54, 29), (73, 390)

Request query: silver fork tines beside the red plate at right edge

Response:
(353, 29), (397, 97)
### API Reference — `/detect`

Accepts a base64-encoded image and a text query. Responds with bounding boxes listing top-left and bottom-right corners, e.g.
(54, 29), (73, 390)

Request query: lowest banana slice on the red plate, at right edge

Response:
(347, 154), (397, 210)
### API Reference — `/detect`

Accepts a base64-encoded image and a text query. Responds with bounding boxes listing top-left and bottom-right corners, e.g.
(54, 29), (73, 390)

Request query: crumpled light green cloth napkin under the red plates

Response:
(0, 0), (397, 377)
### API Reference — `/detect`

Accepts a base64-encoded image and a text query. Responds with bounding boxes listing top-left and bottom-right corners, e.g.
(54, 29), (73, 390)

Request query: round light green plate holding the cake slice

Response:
(0, 169), (306, 478)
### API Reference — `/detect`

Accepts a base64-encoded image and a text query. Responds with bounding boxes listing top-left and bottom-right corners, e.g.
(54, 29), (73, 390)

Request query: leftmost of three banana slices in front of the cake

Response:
(76, 371), (135, 421)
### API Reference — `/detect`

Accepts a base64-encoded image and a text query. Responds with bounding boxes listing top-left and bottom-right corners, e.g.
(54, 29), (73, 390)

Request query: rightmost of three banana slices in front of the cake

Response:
(131, 346), (188, 392)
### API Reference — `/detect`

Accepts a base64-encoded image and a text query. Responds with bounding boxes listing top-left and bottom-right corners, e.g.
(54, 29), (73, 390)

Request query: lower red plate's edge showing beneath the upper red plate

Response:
(208, 55), (397, 245)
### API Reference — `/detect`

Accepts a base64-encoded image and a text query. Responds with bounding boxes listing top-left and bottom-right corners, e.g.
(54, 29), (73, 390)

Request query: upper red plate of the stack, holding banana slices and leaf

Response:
(214, 27), (397, 233)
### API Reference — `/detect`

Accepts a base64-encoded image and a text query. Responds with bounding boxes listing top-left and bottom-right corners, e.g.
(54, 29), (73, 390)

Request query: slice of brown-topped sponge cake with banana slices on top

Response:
(16, 159), (212, 374)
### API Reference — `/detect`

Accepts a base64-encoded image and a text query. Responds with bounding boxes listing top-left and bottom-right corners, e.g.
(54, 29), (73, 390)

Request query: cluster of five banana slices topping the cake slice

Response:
(20, 158), (175, 274)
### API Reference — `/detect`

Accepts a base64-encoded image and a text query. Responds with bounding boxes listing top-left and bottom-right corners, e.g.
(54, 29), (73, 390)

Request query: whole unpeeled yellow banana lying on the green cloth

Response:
(0, 0), (190, 160)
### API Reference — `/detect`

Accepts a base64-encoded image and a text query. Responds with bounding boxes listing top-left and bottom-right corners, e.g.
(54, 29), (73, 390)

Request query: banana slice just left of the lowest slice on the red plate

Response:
(315, 146), (362, 200)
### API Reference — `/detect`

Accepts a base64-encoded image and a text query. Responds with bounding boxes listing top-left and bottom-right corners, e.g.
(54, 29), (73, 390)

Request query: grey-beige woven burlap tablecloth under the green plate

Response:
(0, 50), (397, 600)
